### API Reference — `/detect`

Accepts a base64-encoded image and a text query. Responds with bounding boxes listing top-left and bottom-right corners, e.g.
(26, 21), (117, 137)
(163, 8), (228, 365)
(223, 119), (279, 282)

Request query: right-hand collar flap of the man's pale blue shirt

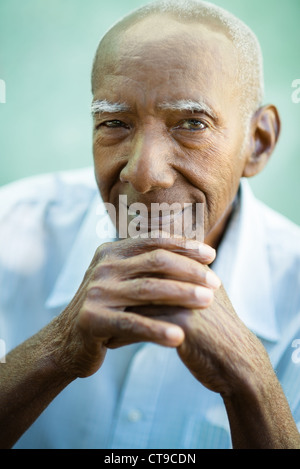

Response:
(213, 179), (280, 341)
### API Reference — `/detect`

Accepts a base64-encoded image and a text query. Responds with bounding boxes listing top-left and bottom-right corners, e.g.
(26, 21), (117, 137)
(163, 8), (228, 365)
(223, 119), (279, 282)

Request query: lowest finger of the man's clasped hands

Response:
(79, 305), (184, 347)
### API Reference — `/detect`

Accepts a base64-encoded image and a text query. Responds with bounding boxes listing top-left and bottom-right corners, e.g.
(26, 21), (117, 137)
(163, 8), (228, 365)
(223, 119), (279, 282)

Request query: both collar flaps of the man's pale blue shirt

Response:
(46, 180), (279, 341)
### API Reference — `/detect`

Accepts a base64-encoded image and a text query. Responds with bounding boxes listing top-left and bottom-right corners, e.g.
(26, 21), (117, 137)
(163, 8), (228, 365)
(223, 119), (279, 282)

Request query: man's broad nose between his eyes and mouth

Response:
(120, 127), (176, 194)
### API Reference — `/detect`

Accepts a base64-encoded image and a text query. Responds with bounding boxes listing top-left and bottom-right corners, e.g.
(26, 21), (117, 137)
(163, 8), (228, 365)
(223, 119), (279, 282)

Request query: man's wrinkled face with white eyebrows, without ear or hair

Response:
(93, 17), (251, 244)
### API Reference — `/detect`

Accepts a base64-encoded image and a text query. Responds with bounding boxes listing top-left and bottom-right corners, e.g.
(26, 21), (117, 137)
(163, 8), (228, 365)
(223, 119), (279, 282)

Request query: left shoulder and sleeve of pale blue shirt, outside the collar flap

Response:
(0, 168), (95, 352)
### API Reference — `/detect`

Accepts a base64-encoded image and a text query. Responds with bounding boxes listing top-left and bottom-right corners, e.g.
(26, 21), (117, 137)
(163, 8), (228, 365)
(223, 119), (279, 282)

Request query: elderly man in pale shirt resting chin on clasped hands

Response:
(0, 0), (300, 448)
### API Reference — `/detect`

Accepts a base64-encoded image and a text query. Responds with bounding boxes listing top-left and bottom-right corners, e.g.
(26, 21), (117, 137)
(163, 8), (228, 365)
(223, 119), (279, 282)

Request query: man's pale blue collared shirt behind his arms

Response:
(0, 169), (300, 449)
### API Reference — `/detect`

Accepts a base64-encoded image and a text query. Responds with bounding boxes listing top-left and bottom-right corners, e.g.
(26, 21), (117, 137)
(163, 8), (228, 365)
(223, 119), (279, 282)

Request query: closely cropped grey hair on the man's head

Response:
(92, 0), (264, 126)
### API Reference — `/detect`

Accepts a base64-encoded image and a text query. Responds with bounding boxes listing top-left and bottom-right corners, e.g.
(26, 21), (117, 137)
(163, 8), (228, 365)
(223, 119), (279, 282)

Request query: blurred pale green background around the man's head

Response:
(0, 0), (300, 224)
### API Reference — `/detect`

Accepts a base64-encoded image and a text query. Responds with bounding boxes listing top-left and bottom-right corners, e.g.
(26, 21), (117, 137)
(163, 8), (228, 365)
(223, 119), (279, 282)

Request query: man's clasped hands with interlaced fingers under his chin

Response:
(63, 234), (266, 395)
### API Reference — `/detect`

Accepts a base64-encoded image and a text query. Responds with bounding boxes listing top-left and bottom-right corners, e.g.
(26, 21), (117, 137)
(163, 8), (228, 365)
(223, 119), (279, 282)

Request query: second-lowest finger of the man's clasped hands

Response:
(91, 277), (214, 308)
